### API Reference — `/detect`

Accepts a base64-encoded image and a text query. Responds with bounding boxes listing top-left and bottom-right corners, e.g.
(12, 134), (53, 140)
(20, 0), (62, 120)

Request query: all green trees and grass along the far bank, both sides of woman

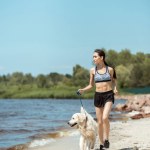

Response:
(0, 49), (150, 99)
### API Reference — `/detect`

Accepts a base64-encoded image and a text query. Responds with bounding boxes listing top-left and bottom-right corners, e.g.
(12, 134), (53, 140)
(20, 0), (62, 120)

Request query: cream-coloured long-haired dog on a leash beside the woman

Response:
(68, 107), (97, 150)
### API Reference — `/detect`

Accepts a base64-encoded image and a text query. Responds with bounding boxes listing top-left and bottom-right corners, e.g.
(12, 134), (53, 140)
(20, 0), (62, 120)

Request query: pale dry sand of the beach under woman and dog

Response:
(28, 118), (150, 150)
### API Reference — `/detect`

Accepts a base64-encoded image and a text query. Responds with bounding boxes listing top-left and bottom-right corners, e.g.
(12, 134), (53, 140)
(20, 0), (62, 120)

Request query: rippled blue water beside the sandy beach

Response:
(0, 99), (125, 148)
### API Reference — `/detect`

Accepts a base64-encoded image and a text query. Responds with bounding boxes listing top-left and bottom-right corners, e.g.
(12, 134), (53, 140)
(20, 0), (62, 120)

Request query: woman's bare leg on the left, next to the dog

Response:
(95, 107), (104, 145)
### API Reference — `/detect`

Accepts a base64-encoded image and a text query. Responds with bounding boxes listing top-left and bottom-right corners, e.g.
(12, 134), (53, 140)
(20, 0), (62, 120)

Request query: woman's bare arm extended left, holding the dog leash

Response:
(78, 68), (94, 94)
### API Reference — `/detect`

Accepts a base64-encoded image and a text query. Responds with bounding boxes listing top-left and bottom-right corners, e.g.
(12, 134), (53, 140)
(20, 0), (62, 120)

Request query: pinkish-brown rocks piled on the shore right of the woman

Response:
(114, 94), (150, 119)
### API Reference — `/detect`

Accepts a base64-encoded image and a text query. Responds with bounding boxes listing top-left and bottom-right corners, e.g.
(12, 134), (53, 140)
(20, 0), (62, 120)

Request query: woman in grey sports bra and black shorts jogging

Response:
(78, 49), (118, 150)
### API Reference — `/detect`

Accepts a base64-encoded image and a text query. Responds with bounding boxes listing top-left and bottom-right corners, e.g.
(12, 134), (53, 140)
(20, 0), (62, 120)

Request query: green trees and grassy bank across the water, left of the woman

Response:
(0, 65), (91, 98)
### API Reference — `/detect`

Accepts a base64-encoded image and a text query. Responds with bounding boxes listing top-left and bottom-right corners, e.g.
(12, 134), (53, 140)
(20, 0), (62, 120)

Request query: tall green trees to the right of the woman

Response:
(106, 49), (150, 88)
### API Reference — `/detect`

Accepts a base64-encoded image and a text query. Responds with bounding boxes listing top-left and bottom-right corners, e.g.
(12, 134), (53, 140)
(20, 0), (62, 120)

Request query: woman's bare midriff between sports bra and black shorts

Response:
(95, 81), (112, 92)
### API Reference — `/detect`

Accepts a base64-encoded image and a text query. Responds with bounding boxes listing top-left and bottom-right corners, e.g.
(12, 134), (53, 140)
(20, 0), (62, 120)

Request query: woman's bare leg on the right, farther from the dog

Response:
(102, 102), (112, 140)
